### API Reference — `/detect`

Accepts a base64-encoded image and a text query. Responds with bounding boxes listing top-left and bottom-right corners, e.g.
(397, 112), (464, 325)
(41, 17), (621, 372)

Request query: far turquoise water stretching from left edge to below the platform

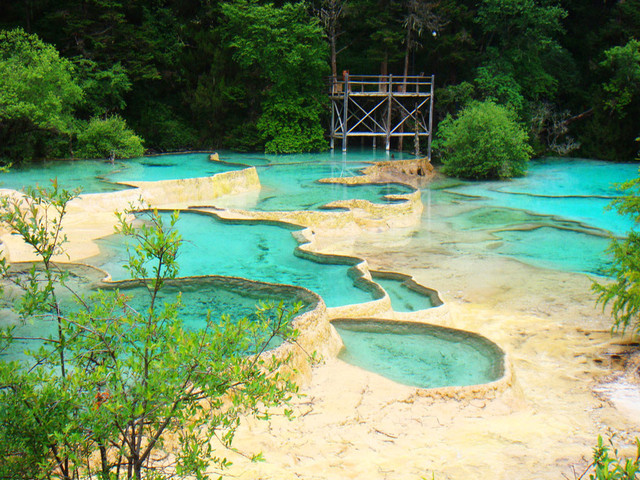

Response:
(0, 150), (413, 211)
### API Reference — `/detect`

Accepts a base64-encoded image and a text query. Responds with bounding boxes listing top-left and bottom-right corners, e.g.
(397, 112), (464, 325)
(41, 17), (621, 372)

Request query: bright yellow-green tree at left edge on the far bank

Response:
(0, 29), (82, 161)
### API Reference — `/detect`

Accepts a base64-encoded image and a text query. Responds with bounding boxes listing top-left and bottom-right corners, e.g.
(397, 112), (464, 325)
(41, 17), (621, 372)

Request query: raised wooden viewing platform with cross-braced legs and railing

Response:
(330, 72), (434, 159)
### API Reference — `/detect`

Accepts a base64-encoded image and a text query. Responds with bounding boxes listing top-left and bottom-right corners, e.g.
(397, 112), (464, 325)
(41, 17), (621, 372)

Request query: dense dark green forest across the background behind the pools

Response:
(0, 0), (640, 164)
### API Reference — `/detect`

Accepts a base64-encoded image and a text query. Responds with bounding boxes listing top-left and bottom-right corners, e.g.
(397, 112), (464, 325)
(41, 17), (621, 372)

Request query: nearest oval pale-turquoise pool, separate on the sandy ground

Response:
(332, 320), (503, 388)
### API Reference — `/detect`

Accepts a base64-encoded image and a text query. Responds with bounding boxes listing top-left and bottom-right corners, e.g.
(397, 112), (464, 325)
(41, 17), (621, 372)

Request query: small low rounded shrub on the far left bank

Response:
(77, 115), (144, 158)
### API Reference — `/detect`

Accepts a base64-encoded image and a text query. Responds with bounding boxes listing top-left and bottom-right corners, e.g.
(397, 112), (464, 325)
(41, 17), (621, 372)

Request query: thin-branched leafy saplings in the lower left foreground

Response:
(0, 184), (297, 480)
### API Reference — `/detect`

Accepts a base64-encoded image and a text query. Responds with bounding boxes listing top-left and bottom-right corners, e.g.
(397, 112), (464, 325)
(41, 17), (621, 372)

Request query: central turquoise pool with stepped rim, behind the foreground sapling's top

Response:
(90, 212), (375, 307)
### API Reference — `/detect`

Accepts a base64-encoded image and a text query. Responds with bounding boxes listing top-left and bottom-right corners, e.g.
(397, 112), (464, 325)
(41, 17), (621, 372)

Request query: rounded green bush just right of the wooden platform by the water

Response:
(435, 101), (533, 179)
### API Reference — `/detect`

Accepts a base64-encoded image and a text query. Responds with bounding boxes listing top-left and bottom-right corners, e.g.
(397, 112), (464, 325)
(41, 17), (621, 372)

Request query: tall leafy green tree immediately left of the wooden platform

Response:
(222, 0), (329, 153)
